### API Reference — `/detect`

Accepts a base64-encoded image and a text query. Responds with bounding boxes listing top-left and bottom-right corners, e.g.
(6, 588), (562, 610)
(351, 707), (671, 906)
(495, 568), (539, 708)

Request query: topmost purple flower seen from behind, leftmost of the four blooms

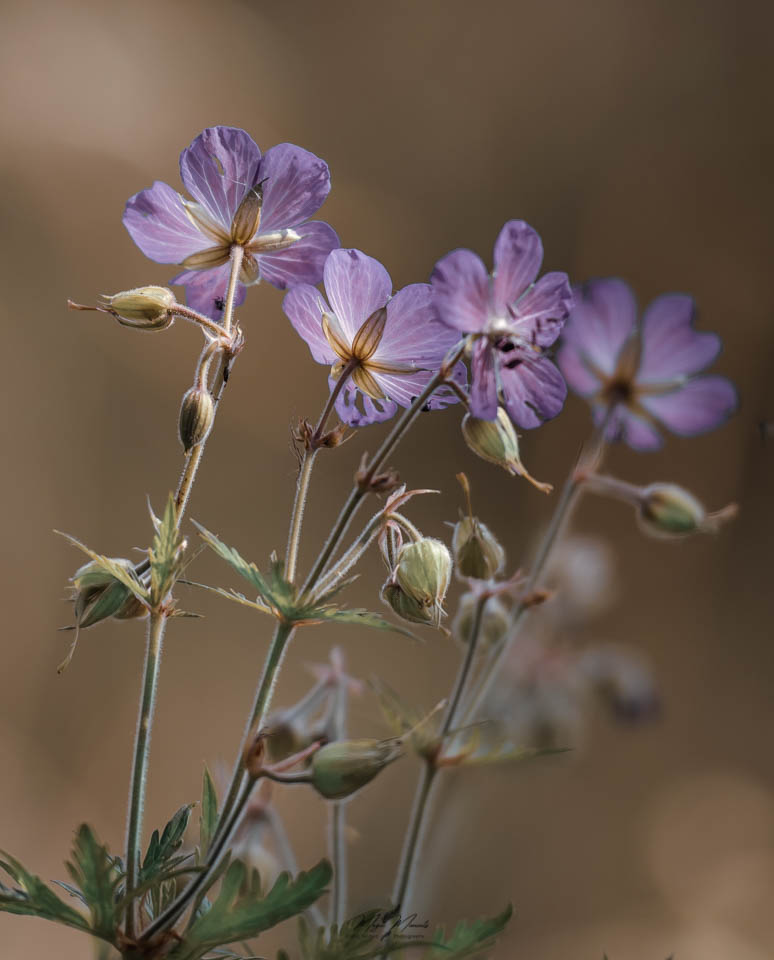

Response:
(124, 127), (339, 319)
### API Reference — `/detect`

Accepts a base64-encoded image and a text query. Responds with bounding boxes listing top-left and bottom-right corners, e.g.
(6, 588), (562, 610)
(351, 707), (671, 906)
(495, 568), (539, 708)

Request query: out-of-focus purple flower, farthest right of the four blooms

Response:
(557, 278), (737, 450)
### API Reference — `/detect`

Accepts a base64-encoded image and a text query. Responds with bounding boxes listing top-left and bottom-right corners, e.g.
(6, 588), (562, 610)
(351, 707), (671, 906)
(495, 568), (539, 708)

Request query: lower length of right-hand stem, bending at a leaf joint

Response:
(392, 594), (489, 912)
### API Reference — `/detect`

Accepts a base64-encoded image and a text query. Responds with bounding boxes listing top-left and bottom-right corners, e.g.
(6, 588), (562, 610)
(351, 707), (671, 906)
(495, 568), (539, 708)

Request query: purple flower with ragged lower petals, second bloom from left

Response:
(282, 249), (465, 426)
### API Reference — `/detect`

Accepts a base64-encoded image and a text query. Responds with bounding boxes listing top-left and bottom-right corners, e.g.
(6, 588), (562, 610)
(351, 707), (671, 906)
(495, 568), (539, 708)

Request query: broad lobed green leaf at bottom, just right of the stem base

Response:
(170, 860), (332, 960)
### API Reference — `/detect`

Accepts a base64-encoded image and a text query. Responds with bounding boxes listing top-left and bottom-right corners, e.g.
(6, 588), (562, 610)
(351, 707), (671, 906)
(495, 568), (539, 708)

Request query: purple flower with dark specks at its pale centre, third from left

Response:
(430, 220), (572, 428)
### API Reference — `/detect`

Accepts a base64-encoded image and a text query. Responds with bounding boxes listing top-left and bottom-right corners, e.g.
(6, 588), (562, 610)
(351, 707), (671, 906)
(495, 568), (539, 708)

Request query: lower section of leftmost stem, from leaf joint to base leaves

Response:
(126, 610), (167, 938)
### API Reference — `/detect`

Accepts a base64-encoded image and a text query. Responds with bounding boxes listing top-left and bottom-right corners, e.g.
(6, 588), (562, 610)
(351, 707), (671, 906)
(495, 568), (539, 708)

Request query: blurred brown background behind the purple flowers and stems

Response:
(0, 0), (774, 960)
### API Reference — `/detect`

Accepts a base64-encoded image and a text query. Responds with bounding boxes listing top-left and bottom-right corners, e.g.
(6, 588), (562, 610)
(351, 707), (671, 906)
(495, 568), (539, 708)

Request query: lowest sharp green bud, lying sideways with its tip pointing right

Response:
(312, 740), (401, 800)
